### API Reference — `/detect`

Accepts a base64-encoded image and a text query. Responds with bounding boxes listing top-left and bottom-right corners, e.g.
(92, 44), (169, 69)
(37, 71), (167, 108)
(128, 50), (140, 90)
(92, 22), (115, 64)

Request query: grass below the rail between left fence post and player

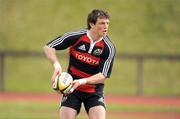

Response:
(5, 54), (67, 92)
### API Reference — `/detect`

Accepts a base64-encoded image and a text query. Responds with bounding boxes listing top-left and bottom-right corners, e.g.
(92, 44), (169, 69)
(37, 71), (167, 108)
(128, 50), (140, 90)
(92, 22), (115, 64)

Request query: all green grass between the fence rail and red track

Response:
(5, 56), (180, 96)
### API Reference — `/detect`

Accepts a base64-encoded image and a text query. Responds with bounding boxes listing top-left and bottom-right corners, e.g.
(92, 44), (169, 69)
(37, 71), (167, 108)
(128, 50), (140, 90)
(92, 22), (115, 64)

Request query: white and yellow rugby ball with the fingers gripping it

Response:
(53, 72), (73, 94)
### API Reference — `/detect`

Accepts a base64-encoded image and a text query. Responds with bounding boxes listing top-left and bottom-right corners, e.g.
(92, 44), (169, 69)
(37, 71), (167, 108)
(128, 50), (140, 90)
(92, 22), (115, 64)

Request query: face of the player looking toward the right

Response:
(90, 18), (109, 37)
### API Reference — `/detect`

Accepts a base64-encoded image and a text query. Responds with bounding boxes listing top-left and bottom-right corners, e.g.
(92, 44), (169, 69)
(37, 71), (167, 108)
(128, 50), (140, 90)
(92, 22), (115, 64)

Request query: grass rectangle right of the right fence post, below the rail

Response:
(144, 60), (180, 96)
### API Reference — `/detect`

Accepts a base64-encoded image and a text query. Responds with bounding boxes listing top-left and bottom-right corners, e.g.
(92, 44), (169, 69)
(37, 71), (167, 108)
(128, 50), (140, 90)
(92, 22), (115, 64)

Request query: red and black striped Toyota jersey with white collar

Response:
(47, 29), (115, 92)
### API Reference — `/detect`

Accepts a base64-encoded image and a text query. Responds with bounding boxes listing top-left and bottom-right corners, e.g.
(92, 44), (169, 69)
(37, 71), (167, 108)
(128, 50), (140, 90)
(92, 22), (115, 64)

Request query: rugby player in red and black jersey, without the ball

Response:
(44, 9), (115, 119)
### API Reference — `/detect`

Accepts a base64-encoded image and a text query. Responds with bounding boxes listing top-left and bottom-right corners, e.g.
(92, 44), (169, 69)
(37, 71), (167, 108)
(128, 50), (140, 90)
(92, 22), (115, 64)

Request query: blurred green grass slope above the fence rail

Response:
(0, 0), (180, 54)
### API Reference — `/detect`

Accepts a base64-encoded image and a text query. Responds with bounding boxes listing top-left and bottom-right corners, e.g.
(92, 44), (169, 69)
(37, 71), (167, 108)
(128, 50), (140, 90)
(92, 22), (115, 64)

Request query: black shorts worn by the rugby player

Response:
(61, 90), (105, 113)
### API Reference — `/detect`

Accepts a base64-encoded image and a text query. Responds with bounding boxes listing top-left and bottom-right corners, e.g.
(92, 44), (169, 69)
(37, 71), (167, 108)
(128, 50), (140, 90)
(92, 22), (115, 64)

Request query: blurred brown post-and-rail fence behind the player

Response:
(0, 51), (180, 95)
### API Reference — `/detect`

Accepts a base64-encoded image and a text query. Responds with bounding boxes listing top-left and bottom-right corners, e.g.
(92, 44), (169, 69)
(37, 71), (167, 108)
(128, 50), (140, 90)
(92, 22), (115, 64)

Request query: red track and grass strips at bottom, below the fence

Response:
(0, 93), (180, 119)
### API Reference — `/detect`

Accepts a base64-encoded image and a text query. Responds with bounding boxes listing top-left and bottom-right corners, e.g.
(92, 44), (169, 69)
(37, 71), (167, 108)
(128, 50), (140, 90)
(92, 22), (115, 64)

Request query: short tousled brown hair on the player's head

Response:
(87, 9), (110, 29)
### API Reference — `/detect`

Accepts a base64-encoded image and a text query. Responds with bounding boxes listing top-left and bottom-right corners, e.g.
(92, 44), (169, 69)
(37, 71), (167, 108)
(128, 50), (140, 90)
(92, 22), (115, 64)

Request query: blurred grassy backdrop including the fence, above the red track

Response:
(0, 0), (180, 119)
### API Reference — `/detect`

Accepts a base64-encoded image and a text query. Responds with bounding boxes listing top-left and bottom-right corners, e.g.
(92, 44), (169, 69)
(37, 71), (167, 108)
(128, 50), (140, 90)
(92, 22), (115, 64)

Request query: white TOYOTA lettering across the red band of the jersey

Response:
(75, 53), (99, 65)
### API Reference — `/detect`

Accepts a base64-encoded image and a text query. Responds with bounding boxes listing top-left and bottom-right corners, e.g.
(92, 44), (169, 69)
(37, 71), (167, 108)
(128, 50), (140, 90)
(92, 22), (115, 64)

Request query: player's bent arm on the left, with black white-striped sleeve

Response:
(44, 30), (87, 84)
